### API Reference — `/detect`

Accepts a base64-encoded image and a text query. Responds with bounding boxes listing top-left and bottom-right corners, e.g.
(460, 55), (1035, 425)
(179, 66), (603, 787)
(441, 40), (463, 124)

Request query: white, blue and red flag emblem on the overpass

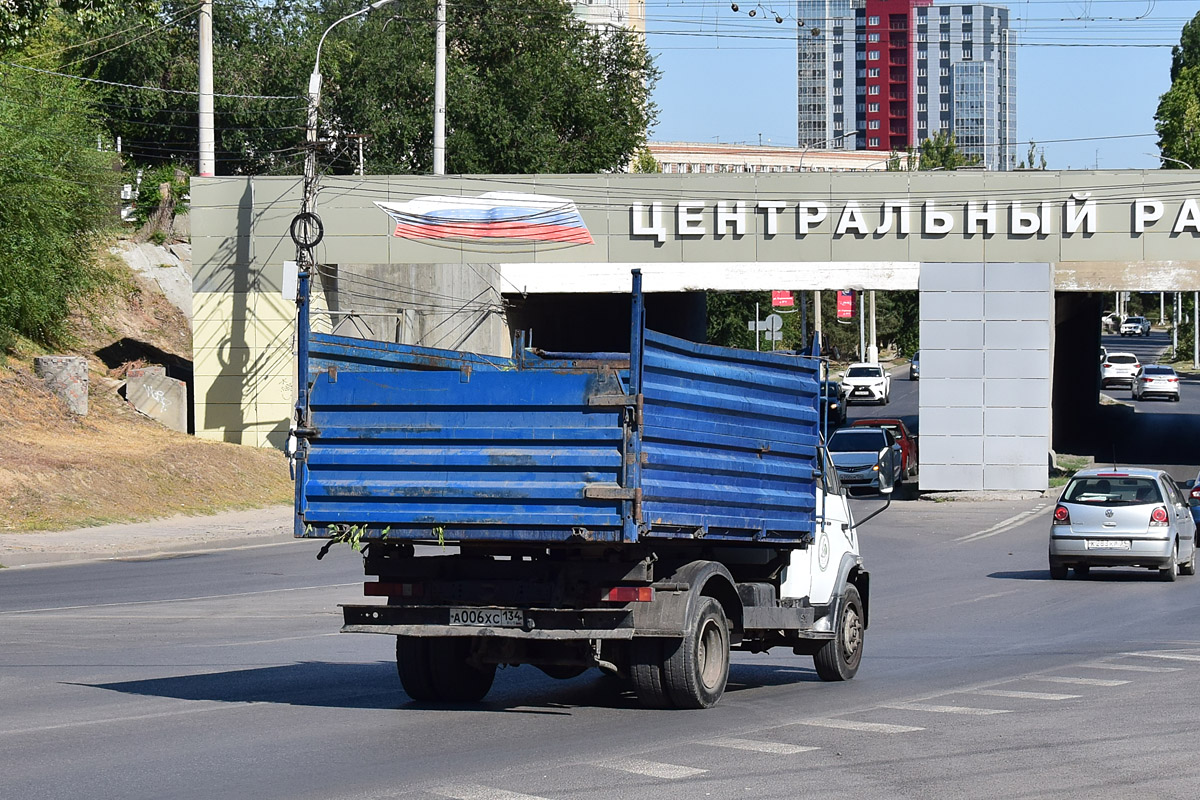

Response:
(376, 192), (593, 245)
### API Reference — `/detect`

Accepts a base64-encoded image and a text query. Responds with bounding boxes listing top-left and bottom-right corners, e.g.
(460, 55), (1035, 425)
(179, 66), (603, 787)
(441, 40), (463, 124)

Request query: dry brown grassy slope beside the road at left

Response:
(0, 250), (292, 530)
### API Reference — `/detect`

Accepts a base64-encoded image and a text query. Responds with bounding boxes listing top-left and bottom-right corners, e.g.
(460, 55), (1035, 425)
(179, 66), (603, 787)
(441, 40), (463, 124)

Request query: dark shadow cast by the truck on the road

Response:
(82, 661), (821, 715)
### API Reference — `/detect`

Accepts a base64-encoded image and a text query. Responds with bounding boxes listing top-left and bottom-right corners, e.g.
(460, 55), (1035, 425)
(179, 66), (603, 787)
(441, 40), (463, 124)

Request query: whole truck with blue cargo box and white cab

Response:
(293, 272), (870, 708)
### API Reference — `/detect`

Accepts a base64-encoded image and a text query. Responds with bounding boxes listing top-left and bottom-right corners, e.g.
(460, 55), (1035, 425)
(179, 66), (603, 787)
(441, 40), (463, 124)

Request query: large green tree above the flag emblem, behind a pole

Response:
(322, 0), (658, 174)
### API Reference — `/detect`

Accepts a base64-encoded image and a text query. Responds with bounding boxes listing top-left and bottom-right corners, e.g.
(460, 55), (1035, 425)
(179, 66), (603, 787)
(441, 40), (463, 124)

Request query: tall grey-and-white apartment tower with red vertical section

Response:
(797, 0), (1016, 169)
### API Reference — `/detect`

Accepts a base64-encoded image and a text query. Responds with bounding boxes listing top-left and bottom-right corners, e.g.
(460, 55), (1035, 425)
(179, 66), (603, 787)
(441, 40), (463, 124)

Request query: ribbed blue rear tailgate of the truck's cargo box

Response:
(298, 335), (628, 541)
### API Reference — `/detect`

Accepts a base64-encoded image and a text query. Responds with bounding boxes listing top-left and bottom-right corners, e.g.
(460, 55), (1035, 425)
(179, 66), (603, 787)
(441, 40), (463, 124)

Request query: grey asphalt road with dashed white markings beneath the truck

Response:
(0, 500), (1200, 800)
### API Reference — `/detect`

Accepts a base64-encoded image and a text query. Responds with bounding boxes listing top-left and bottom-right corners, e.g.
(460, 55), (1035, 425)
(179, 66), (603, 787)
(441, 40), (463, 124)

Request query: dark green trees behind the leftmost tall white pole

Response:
(72, 0), (316, 174)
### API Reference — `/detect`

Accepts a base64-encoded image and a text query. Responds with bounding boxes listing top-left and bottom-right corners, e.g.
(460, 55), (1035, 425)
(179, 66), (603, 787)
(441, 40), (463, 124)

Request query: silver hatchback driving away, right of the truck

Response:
(1050, 468), (1196, 581)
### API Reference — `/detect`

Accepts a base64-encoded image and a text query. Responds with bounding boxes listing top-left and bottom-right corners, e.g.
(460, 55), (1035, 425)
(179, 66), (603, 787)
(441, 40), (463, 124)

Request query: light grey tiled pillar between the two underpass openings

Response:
(919, 264), (1054, 491)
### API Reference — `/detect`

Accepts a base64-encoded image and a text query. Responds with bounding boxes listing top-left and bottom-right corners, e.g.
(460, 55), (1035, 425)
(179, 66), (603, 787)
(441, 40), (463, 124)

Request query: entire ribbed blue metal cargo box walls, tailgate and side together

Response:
(296, 332), (818, 545)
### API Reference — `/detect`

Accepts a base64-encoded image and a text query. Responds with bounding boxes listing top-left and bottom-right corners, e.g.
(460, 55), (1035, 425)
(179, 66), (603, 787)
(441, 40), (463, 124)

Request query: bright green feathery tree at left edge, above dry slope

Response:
(0, 53), (120, 350)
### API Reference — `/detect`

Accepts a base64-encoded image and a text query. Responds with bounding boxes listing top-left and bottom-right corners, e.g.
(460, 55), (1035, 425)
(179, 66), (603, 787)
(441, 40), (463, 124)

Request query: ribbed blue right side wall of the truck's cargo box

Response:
(642, 331), (820, 543)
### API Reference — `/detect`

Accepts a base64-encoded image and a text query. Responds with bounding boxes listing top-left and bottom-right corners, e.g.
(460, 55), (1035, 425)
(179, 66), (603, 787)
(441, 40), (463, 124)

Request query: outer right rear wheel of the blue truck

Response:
(664, 597), (730, 709)
